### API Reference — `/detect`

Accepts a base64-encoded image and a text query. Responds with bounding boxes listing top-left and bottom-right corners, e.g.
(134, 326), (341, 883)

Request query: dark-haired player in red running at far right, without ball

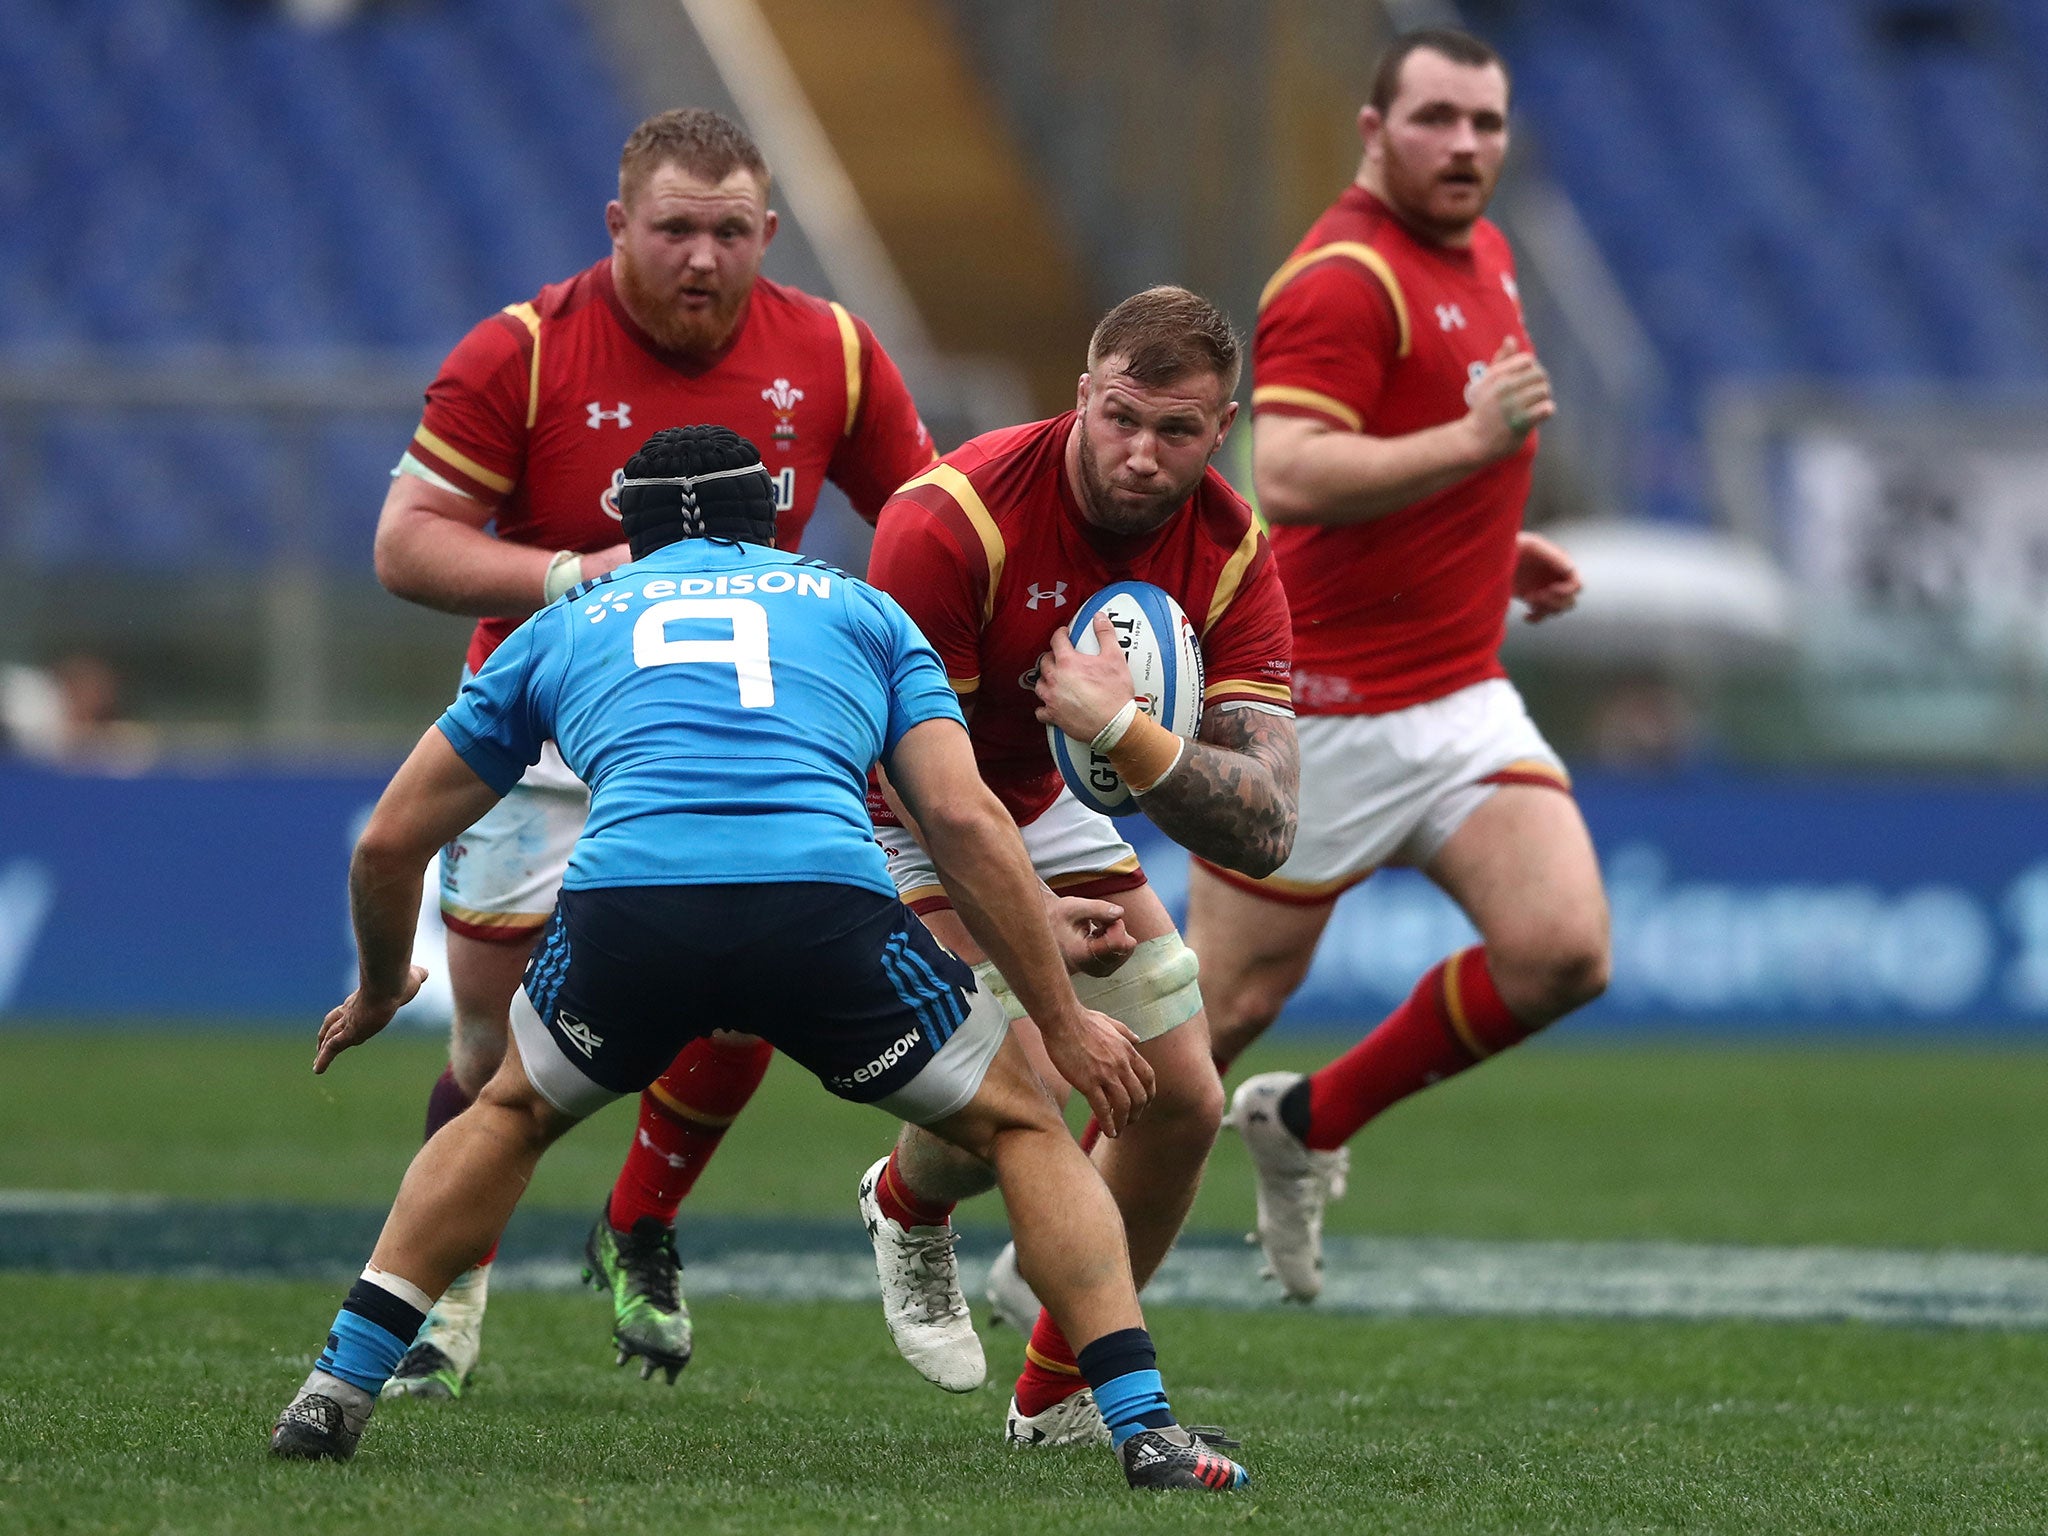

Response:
(1188, 31), (1608, 1300)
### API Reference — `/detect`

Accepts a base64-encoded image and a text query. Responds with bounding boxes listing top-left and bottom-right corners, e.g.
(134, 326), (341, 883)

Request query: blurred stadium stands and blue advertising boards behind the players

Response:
(0, 0), (2048, 1034)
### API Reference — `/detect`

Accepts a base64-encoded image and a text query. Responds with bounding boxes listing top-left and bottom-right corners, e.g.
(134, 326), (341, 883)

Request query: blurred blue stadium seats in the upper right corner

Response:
(1466, 0), (2048, 518)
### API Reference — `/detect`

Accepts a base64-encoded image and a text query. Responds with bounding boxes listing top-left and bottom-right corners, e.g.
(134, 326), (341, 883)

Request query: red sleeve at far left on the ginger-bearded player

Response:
(412, 305), (539, 508)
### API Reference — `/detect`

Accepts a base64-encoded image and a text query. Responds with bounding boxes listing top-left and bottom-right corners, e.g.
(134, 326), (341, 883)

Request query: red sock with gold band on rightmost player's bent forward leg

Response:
(1307, 944), (1534, 1151)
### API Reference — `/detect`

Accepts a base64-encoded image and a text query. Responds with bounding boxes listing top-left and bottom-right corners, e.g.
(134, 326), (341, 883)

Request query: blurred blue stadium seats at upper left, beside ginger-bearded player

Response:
(0, 0), (637, 569)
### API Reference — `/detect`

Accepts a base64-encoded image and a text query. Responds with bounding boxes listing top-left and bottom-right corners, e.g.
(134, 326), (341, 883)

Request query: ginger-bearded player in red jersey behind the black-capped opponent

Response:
(377, 109), (932, 1397)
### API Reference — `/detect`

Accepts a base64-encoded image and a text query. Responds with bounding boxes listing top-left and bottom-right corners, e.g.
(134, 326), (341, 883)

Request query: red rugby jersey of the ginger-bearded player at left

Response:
(412, 258), (932, 670)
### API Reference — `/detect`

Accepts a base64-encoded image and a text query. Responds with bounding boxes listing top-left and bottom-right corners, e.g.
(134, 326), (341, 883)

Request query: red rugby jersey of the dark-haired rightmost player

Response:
(1251, 186), (1536, 715)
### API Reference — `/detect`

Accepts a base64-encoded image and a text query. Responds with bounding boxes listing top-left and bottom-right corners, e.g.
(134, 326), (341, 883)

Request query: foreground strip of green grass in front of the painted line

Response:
(0, 1276), (2048, 1536)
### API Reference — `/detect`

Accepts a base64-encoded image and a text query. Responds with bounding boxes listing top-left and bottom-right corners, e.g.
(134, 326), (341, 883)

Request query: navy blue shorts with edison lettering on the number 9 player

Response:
(512, 883), (1004, 1120)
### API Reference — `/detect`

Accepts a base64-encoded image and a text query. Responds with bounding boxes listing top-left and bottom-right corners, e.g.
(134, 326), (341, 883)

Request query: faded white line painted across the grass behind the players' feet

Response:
(12, 1190), (2048, 1329)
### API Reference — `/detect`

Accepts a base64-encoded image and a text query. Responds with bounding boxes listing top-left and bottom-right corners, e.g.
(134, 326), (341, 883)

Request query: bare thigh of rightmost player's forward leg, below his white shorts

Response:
(1425, 784), (1608, 950)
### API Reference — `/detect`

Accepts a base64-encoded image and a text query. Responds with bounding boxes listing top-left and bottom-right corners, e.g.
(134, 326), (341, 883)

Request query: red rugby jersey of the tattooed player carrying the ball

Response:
(868, 412), (1288, 825)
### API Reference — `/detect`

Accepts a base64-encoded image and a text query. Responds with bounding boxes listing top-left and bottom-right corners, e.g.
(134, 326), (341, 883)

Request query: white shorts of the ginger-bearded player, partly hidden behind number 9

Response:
(440, 741), (590, 944)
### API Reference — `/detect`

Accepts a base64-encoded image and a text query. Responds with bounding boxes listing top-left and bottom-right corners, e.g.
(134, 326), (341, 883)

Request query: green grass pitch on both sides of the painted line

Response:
(0, 1032), (2048, 1536)
